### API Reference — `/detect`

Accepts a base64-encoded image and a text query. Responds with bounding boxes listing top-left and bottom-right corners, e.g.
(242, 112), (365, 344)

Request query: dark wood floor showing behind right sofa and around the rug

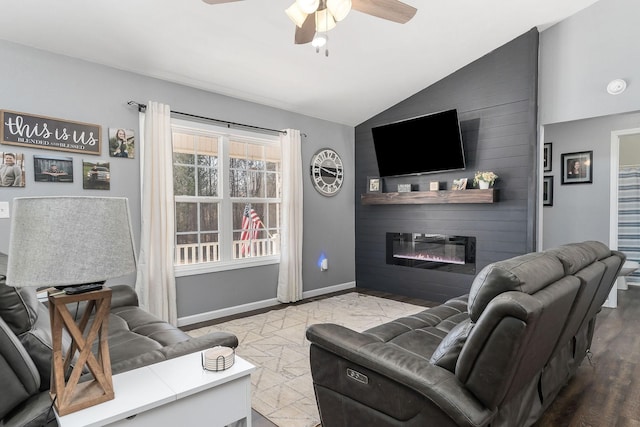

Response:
(194, 286), (640, 427)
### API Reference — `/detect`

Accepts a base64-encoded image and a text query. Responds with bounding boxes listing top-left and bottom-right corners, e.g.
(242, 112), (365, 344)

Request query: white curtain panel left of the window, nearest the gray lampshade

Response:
(136, 101), (178, 325)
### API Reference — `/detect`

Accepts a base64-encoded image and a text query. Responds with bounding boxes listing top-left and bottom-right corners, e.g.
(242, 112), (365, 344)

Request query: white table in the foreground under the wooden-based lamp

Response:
(56, 352), (256, 427)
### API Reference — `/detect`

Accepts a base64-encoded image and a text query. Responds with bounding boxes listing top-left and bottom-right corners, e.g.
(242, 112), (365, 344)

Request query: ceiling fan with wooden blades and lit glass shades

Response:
(202, 0), (417, 47)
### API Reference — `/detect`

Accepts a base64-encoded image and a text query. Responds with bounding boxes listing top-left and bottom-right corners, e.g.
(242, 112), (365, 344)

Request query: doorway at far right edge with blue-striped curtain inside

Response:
(609, 128), (640, 307)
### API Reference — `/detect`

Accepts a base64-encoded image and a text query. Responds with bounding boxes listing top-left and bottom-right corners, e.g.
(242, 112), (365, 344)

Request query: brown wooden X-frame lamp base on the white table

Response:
(49, 288), (114, 416)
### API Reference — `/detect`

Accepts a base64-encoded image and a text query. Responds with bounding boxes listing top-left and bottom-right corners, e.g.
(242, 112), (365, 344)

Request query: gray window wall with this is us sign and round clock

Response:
(0, 41), (355, 324)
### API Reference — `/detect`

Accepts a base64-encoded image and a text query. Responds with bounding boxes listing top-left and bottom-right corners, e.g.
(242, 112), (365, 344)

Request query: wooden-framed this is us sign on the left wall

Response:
(0, 110), (102, 155)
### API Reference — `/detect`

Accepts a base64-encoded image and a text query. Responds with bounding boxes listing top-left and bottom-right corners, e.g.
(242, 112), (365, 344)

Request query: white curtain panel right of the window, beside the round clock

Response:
(277, 129), (302, 303)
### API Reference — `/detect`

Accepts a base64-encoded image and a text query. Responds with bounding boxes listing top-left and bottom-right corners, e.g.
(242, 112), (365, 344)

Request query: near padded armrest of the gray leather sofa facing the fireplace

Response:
(306, 323), (493, 426)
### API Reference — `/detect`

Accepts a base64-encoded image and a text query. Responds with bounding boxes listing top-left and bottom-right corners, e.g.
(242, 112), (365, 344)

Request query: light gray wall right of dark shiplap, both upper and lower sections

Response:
(539, 0), (640, 248)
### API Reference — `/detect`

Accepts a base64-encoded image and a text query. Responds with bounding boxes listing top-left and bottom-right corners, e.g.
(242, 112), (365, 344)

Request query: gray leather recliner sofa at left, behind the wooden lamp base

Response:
(0, 254), (238, 427)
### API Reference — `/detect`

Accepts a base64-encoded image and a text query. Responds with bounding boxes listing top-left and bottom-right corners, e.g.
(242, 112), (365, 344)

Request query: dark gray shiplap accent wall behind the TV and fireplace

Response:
(355, 29), (538, 302)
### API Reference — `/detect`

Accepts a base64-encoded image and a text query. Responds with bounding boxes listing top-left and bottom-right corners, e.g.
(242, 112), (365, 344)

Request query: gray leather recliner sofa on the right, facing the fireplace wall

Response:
(306, 241), (625, 427)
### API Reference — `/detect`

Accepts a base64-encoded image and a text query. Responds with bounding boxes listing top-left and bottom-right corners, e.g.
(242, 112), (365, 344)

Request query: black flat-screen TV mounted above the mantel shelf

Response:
(371, 109), (466, 177)
